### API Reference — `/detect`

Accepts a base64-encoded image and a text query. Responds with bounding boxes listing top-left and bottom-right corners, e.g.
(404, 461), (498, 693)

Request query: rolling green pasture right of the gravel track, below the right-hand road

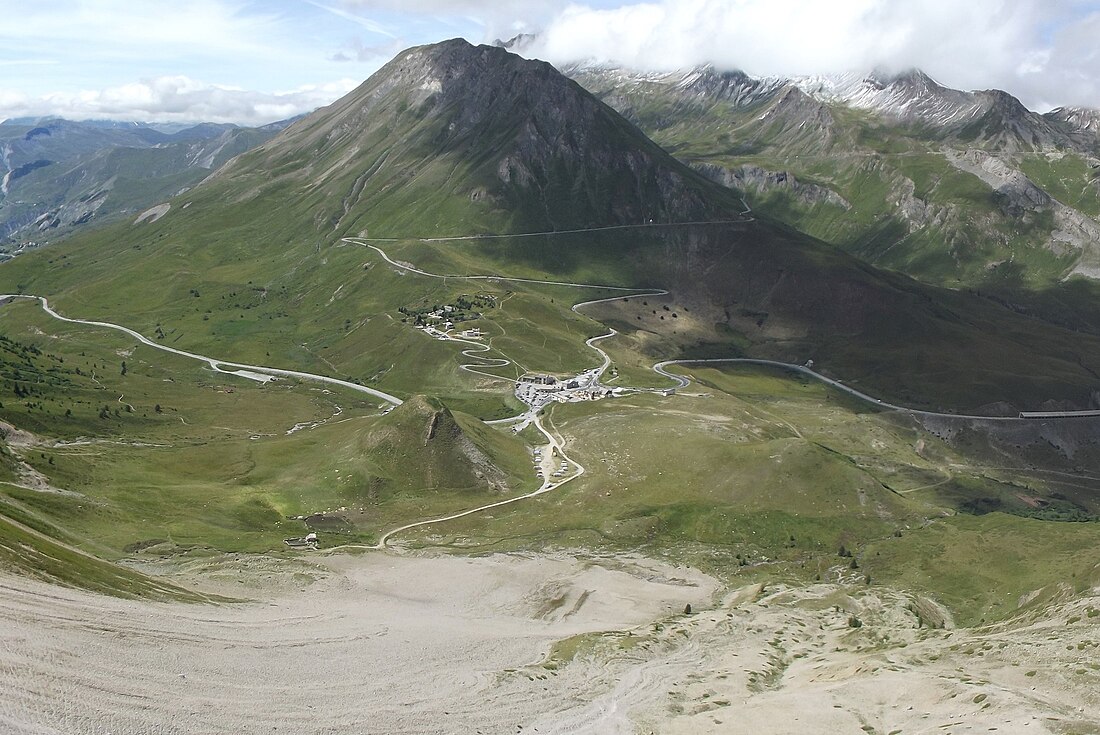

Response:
(400, 366), (1100, 625)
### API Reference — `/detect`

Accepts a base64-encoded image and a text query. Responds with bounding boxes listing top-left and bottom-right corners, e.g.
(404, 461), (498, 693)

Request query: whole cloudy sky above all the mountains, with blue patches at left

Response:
(0, 0), (1100, 124)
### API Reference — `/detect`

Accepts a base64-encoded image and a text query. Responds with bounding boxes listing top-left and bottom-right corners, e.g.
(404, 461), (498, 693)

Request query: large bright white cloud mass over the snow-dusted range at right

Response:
(514, 0), (1100, 107)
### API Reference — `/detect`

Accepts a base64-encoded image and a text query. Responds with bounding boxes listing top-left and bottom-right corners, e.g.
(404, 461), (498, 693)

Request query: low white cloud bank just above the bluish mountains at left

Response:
(0, 76), (359, 125)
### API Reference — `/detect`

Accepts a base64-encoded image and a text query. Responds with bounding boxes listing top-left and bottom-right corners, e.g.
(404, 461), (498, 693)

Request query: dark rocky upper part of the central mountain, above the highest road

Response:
(219, 39), (740, 234)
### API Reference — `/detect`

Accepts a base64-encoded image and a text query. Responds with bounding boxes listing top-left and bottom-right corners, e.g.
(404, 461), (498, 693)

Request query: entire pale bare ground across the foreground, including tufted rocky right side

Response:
(0, 553), (1100, 735)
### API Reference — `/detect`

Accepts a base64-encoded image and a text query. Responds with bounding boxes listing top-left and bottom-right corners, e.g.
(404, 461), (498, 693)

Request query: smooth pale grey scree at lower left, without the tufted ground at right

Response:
(0, 553), (716, 735)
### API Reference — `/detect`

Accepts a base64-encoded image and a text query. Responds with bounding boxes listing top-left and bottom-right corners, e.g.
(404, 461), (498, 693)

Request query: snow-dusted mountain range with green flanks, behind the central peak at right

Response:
(565, 65), (1100, 290)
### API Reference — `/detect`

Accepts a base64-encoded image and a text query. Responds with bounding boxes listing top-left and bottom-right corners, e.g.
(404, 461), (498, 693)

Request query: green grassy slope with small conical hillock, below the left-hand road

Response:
(0, 294), (534, 596)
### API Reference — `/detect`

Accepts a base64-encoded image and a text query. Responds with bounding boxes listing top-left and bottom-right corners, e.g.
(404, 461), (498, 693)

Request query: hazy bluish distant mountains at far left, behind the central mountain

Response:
(0, 118), (289, 249)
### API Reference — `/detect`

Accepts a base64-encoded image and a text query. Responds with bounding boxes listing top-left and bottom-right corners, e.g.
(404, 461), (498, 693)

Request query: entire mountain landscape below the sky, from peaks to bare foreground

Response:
(0, 40), (1100, 734)
